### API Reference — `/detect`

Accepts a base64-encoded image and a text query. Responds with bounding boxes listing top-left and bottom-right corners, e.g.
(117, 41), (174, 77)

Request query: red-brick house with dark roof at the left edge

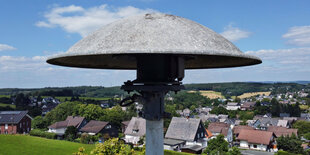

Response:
(0, 111), (32, 134)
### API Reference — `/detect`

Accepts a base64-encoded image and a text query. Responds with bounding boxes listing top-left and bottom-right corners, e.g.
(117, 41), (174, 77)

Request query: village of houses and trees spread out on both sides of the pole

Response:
(0, 84), (310, 154)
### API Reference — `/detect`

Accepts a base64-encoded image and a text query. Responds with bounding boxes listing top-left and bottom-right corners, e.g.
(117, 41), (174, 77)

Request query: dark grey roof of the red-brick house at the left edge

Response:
(0, 111), (30, 124)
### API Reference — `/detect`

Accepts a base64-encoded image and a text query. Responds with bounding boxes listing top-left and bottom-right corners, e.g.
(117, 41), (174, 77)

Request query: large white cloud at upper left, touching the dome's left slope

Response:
(36, 5), (155, 37)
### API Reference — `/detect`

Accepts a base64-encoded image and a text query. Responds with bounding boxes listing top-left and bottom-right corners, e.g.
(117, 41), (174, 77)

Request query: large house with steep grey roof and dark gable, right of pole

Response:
(164, 117), (207, 151)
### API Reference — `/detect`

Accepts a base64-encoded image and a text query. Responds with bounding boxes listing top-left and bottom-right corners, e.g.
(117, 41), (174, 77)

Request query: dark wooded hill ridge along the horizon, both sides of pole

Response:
(0, 82), (310, 97)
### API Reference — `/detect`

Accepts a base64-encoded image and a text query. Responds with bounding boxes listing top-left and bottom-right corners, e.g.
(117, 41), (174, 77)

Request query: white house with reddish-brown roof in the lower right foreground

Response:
(237, 129), (276, 151)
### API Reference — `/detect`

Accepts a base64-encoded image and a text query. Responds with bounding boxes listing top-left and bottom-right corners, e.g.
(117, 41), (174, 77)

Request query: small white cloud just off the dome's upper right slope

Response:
(220, 24), (251, 42)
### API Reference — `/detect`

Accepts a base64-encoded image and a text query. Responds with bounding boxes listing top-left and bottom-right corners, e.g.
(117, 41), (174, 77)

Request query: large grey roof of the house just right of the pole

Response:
(165, 117), (201, 141)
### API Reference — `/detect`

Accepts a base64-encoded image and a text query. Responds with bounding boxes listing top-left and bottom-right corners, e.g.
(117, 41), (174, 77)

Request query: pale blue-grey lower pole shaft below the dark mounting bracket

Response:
(145, 119), (164, 155)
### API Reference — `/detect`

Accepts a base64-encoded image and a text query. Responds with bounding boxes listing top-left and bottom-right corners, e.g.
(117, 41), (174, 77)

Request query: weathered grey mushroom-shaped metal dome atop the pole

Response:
(47, 13), (262, 69)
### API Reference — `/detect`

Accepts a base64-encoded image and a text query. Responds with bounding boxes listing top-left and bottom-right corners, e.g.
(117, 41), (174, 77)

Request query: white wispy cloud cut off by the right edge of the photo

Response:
(282, 26), (310, 46)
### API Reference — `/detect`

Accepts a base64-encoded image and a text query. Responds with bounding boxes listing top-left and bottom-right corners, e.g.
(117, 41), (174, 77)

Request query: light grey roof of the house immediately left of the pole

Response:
(124, 117), (146, 136)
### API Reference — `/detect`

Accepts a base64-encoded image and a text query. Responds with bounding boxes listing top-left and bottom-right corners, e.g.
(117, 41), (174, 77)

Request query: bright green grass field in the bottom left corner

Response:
(0, 135), (95, 155)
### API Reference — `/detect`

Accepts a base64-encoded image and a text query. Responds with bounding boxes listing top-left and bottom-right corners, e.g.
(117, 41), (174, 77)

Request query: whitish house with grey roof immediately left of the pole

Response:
(124, 117), (146, 145)
